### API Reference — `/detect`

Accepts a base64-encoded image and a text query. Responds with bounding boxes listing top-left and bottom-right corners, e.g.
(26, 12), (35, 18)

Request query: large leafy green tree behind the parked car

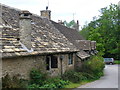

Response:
(80, 4), (120, 59)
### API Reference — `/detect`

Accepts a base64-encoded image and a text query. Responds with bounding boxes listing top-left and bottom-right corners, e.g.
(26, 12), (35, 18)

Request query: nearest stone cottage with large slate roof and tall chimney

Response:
(0, 5), (79, 79)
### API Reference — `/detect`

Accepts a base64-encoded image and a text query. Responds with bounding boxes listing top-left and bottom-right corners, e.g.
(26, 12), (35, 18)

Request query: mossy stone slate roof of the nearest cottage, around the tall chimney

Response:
(0, 5), (78, 58)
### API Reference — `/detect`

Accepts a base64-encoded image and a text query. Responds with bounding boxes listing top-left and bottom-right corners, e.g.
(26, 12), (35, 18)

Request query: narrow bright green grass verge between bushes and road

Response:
(65, 80), (95, 88)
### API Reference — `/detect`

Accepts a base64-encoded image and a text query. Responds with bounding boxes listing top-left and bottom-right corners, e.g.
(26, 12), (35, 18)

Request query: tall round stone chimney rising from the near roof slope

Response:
(19, 11), (32, 50)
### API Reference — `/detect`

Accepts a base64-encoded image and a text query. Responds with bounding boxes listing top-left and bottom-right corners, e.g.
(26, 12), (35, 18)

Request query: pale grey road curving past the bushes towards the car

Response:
(78, 65), (120, 88)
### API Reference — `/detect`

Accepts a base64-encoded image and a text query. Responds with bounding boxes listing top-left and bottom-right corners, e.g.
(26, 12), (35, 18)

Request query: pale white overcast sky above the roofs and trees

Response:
(0, 0), (119, 27)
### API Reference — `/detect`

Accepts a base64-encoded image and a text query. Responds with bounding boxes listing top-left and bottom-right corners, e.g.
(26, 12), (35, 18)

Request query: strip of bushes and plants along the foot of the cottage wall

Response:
(3, 56), (104, 90)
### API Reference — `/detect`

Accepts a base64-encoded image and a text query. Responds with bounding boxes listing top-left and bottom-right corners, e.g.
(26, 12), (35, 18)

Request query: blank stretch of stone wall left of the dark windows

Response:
(2, 56), (45, 79)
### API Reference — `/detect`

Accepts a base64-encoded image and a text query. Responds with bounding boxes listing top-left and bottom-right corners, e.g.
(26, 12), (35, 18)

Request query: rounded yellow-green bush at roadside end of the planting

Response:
(80, 56), (105, 78)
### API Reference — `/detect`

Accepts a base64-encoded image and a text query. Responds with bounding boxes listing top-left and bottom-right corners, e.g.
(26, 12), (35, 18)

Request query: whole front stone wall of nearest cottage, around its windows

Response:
(2, 54), (75, 79)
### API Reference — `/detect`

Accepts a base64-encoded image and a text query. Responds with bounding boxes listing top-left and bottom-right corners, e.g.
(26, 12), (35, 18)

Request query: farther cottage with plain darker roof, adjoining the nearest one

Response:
(41, 10), (96, 68)
